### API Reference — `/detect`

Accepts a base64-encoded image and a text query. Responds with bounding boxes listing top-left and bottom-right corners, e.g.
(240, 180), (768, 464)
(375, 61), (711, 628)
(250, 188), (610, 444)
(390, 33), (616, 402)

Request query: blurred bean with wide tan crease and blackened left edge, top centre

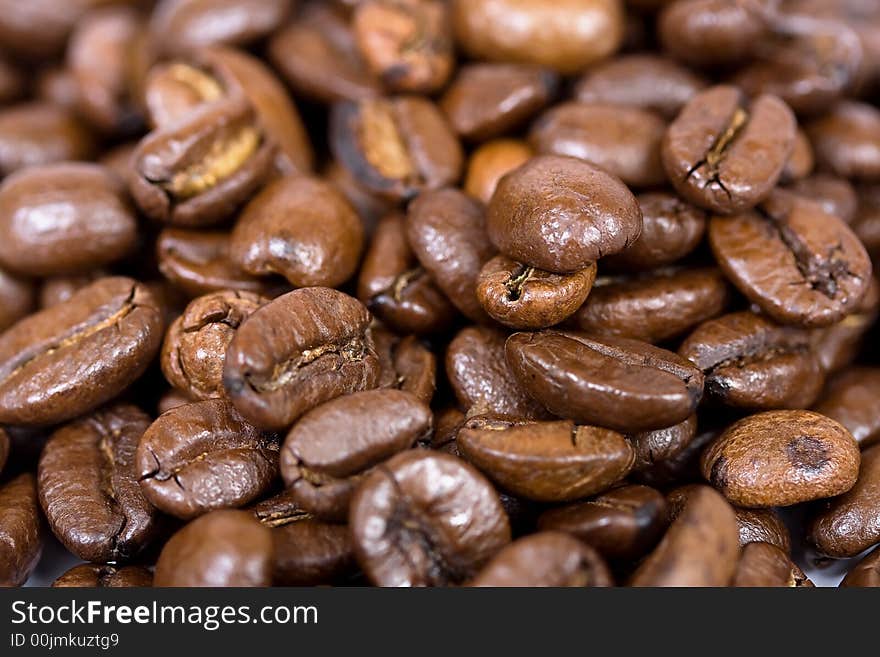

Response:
(330, 96), (464, 200)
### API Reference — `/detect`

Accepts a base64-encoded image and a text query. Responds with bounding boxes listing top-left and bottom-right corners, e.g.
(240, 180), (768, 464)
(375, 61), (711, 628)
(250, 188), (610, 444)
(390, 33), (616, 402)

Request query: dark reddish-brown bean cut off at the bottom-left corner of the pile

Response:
(0, 472), (43, 587)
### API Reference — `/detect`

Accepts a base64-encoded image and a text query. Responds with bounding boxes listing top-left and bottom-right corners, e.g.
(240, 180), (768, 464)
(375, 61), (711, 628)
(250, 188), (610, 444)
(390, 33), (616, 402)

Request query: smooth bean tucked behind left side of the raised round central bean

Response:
(406, 189), (495, 322)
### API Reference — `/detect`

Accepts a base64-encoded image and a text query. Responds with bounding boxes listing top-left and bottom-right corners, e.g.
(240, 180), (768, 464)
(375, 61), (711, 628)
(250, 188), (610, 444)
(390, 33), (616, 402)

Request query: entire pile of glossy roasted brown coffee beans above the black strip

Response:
(0, 0), (880, 587)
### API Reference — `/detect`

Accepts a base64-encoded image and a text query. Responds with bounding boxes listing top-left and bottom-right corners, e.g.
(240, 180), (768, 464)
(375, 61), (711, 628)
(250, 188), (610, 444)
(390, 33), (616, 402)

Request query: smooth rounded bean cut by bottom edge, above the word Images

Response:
(153, 509), (274, 586)
